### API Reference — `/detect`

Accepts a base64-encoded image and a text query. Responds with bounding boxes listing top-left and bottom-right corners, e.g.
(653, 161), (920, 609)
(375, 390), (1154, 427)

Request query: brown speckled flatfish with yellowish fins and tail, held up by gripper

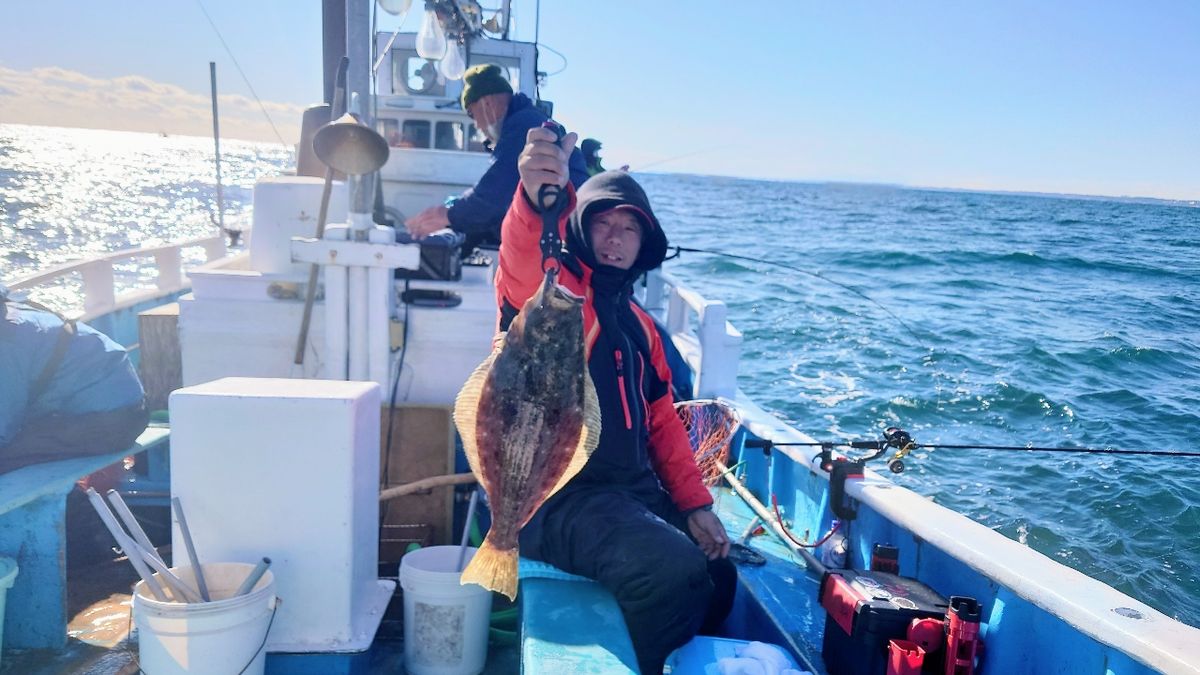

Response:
(454, 269), (600, 599)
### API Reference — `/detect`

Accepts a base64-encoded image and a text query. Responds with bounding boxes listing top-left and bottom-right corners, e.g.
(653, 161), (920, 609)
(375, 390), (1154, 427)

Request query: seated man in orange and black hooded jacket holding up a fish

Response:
(496, 129), (737, 674)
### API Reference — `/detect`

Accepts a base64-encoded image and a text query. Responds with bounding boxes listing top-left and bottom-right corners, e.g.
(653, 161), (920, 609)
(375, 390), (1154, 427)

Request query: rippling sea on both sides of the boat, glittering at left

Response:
(0, 125), (1200, 626)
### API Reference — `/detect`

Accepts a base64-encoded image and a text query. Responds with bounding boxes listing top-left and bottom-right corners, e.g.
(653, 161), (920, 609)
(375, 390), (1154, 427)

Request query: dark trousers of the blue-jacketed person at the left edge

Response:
(0, 404), (150, 473)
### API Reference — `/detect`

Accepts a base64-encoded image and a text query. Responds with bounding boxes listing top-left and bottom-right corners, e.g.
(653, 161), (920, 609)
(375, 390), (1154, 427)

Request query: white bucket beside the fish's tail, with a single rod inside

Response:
(400, 546), (492, 675)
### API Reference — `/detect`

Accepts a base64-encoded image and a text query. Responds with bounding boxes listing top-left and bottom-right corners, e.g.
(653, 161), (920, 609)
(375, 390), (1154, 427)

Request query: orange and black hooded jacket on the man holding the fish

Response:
(496, 171), (713, 513)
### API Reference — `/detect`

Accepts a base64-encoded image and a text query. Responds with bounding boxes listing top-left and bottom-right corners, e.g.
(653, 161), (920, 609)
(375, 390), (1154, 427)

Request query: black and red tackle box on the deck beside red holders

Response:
(821, 569), (949, 675)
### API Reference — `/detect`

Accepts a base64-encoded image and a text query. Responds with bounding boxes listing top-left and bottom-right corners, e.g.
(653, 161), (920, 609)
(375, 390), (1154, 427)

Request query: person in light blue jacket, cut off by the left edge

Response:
(0, 286), (148, 473)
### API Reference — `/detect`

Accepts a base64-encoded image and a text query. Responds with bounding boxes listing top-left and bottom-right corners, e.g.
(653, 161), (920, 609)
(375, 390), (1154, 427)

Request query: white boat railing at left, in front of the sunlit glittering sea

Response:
(8, 234), (226, 321)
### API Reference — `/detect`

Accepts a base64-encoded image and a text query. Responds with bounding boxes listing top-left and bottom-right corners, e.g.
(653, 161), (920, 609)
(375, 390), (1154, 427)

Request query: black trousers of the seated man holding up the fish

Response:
(521, 484), (737, 675)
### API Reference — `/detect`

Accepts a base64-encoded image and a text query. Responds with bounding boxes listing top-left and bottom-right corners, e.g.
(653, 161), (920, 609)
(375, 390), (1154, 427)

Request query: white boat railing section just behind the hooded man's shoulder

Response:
(641, 265), (742, 399)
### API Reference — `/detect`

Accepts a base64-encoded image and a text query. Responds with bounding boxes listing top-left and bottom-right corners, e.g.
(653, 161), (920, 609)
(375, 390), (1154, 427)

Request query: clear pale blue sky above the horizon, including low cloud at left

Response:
(0, 0), (1200, 199)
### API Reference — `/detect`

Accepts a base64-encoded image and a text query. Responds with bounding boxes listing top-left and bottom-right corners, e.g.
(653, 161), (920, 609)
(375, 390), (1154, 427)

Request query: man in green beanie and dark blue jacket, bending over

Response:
(404, 64), (588, 244)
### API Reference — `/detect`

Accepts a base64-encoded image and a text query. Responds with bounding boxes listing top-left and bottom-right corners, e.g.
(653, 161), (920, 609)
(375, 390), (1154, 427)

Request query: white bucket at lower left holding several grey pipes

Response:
(133, 562), (276, 675)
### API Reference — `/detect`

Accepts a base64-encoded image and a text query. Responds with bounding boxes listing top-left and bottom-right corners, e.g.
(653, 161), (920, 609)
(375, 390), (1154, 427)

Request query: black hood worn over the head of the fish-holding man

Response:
(566, 171), (667, 279)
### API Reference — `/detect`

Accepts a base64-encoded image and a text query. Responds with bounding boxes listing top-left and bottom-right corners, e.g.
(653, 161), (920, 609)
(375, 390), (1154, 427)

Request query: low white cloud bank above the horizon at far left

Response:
(0, 66), (304, 144)
